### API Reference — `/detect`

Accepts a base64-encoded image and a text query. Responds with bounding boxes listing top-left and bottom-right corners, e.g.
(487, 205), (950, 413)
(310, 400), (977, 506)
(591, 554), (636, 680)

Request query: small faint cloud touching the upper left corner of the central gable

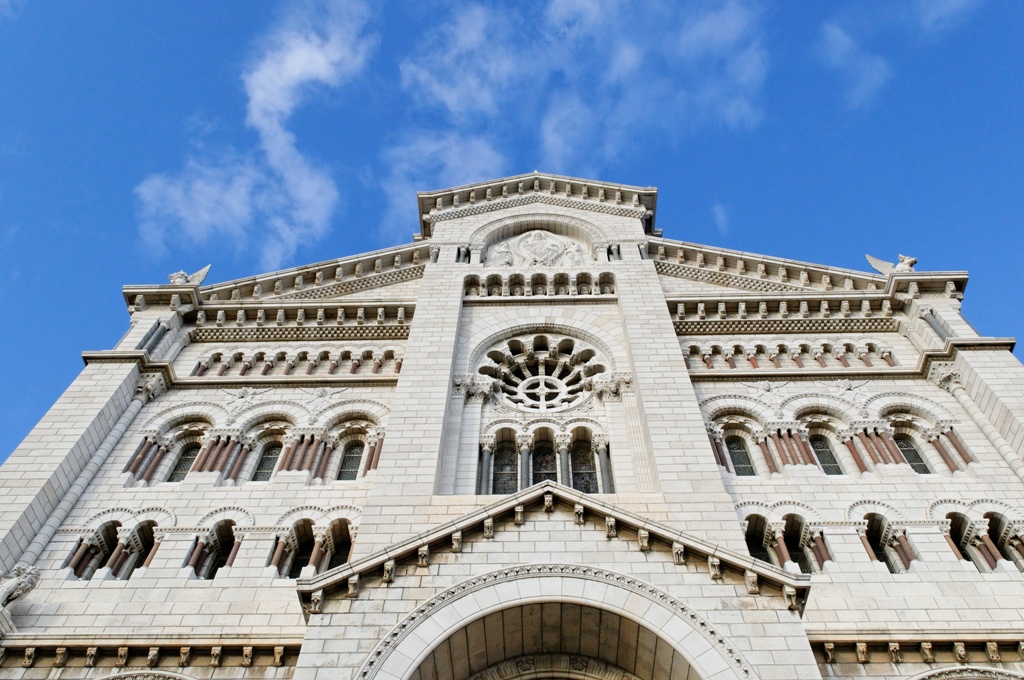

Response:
(381, 131), (506, 241)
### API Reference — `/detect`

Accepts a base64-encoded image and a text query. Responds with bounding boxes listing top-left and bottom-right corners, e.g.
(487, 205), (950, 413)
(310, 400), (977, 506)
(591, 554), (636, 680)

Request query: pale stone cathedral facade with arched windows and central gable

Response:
(0, 173), (1024, 680)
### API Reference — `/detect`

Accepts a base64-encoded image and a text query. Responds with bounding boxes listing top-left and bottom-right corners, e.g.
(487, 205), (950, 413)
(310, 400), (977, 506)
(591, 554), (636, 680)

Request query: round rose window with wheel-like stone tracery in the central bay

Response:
(479, 335), (606, 413)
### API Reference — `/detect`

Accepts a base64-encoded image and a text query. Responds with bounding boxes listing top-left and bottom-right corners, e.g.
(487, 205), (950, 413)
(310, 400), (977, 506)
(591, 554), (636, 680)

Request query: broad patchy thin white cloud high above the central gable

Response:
(400, 0), (769, 179)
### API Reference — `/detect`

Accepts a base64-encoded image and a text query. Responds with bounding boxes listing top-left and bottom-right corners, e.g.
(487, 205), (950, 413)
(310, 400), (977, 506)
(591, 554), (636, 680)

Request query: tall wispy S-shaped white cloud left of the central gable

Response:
(135, 0), (374, 268)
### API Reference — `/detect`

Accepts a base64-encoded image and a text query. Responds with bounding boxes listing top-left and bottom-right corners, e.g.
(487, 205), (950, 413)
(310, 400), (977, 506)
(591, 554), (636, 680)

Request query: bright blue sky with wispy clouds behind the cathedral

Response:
(0, 0), (1024, 460)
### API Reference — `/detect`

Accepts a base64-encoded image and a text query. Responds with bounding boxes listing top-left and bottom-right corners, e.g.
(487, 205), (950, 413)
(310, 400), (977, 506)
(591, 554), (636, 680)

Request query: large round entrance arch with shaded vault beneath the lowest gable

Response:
(355, 564), (757, 680)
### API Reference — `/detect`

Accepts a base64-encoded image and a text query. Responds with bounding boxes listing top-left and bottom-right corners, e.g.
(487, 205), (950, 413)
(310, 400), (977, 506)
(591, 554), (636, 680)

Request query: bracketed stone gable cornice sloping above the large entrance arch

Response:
(296, 481), (810, 613)
